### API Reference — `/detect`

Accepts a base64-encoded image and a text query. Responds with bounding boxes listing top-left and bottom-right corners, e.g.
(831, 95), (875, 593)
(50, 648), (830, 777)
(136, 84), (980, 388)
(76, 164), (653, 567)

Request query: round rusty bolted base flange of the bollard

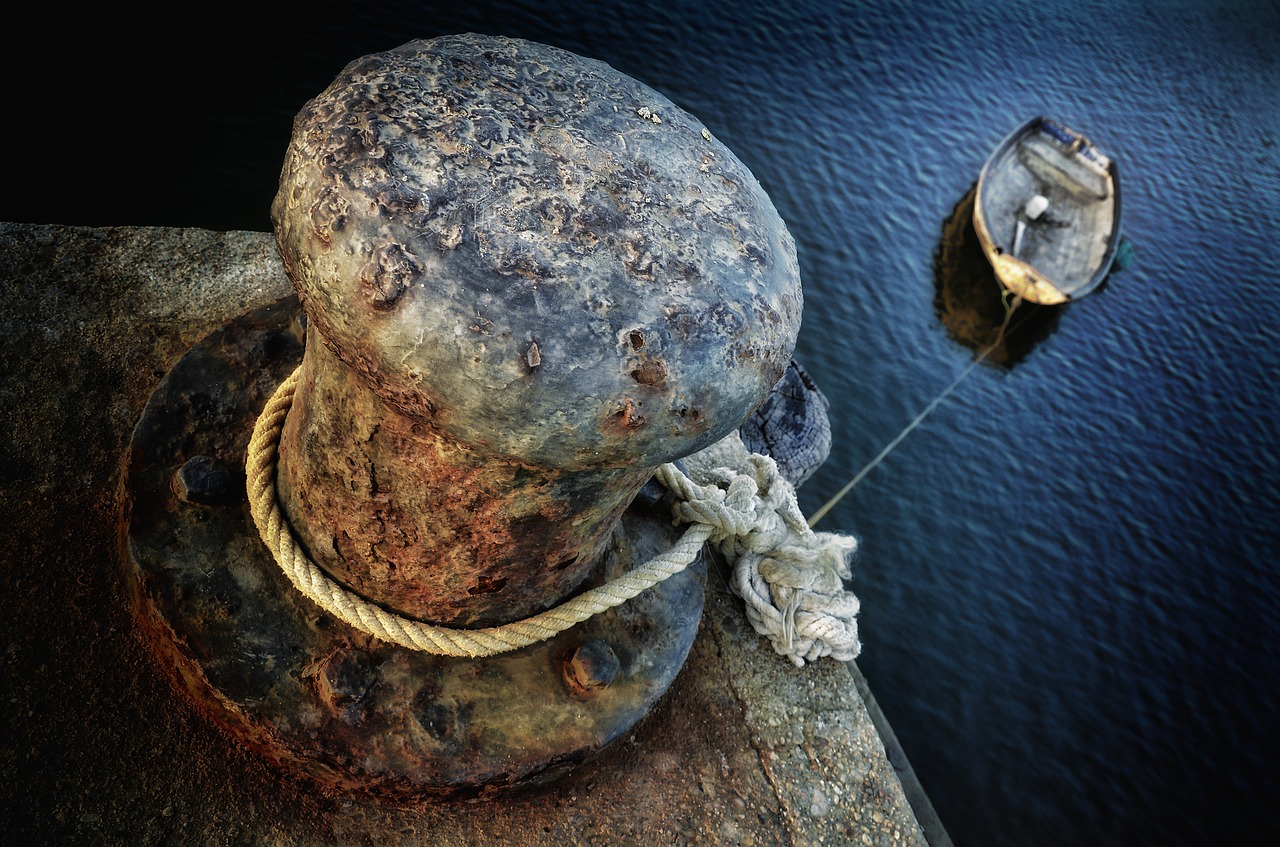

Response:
(120, 298), (707, 800)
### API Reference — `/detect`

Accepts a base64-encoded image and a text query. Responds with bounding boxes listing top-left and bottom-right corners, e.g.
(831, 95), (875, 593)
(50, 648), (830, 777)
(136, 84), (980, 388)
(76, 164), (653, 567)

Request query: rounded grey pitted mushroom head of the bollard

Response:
(271, 35), (803, 467)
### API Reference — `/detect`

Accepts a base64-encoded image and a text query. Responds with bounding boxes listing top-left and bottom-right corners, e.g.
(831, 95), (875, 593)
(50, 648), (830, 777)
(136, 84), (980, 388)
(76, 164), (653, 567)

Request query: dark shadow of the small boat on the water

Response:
(933, 182), (1080, 370)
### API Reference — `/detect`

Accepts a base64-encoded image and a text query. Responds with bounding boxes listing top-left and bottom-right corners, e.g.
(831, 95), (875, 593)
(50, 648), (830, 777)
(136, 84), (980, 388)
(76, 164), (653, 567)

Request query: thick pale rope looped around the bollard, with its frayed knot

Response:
(244, 368), (860, 667)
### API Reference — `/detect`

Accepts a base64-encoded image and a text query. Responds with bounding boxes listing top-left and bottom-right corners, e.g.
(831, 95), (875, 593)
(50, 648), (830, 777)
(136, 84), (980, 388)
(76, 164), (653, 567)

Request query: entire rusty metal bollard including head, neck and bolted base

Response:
(125, 35), (801, 797)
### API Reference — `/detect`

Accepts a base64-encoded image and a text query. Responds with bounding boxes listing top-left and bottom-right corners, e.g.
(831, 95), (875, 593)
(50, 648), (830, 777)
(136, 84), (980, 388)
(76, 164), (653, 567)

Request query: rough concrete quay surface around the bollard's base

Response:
(0, 224), (938, 846)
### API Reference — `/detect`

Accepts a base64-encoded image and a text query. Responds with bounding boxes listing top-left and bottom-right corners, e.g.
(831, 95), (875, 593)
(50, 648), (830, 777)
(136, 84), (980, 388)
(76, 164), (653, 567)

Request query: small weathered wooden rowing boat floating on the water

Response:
(973, 116), (1120, 306)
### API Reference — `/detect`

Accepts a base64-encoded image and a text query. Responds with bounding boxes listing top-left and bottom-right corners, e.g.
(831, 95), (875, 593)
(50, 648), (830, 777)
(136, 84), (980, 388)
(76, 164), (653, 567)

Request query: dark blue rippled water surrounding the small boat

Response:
(0, 0), (1280, 846)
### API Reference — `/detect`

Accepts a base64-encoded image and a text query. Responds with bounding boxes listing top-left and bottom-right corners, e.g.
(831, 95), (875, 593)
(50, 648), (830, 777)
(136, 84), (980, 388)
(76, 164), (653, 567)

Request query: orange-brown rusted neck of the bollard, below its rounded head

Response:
(279, 326), (653, 627)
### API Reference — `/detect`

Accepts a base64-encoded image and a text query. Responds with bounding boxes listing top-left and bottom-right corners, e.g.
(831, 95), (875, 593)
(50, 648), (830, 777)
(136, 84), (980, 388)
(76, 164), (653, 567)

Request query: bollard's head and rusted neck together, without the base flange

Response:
(273, 35), (801, 626)
